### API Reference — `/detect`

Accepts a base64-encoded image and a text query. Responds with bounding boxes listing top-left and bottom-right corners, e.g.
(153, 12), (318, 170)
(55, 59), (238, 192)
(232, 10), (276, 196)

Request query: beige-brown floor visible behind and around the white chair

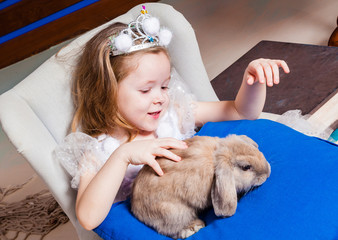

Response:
(0, 0), (338, 240)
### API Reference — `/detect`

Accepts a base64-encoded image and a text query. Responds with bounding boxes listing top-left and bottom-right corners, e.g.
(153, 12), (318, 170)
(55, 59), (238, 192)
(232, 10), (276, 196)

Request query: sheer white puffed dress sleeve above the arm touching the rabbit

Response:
(53, 132), (118, 188)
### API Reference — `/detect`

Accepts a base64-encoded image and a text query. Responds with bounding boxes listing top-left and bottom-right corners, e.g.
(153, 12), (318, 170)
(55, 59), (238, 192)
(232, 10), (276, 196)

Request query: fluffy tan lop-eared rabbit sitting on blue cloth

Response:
(131, 135), (271, 239)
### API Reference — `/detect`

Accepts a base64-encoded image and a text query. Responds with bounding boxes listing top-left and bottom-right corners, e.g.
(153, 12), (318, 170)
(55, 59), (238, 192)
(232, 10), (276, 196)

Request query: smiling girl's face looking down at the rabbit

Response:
(117, 53), (170, 134)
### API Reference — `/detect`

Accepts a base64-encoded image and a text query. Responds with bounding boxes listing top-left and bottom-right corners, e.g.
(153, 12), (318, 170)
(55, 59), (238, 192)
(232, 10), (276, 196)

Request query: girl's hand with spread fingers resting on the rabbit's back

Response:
(115, 138), (188, 176)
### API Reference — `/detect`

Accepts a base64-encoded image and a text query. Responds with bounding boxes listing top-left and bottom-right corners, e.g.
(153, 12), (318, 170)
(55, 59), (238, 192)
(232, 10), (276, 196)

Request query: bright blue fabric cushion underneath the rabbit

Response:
(95, 120), (338, 240)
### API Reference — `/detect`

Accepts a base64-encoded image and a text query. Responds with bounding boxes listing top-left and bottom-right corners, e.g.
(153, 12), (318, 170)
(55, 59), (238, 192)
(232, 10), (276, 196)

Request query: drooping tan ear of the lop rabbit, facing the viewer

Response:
(211, 162), (237, 217)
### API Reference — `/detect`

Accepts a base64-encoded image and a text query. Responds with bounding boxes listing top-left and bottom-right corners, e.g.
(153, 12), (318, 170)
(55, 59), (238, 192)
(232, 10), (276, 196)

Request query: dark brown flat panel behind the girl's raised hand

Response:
(211, 41), (338, 114)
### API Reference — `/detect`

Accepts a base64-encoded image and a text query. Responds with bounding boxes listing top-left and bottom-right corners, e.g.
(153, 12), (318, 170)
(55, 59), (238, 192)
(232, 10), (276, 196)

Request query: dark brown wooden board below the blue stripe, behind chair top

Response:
(0, 0), (156, 69)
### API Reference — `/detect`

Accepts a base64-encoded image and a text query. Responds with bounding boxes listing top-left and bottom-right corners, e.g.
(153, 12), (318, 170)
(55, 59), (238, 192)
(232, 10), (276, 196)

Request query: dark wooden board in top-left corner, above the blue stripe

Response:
(0, 0), (81, 36)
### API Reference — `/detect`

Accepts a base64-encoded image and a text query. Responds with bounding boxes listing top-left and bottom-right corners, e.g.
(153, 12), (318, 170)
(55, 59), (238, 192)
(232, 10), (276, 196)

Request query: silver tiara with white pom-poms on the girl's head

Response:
(108, 6), (172, 56)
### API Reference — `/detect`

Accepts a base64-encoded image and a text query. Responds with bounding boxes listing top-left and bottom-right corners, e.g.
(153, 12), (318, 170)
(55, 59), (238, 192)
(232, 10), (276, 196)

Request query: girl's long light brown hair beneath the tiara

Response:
(72, 23), (169, 141)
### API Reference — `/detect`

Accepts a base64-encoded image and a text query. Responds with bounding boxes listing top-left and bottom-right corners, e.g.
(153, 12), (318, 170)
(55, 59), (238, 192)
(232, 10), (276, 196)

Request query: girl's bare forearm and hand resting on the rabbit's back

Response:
(76, 138), (187, 230)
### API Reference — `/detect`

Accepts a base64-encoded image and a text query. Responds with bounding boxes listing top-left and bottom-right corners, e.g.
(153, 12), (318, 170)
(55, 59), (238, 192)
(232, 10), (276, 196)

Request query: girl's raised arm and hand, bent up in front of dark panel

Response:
(195, 59), (290, 126)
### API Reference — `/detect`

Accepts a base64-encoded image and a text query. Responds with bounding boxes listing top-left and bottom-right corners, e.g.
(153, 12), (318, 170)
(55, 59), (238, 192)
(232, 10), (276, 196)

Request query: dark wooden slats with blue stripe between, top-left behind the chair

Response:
(0, 0), (155, 69)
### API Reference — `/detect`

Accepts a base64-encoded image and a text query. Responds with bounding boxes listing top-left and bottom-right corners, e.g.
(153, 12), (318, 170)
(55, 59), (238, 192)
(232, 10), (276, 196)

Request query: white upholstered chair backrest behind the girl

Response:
(0, 3), (218, 239)
